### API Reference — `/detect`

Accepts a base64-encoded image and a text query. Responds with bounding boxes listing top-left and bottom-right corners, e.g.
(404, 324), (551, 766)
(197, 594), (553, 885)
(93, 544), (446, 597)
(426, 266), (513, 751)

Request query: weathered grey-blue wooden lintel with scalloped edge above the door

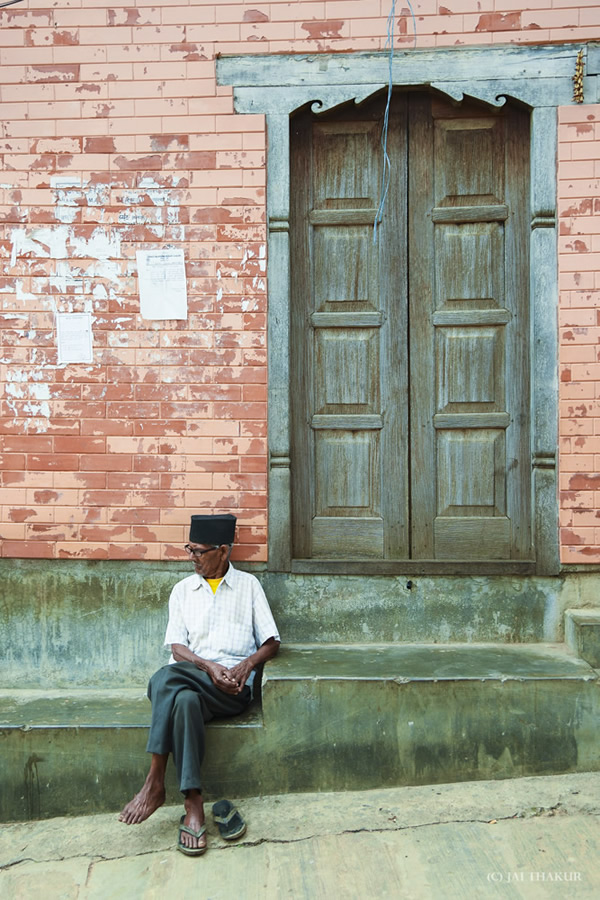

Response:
(217, 44), (600, 114)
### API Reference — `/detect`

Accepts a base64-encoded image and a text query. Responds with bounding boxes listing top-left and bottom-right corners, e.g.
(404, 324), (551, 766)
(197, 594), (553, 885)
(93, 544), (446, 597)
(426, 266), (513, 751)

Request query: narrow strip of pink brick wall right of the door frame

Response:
(558, 105), (600, 563)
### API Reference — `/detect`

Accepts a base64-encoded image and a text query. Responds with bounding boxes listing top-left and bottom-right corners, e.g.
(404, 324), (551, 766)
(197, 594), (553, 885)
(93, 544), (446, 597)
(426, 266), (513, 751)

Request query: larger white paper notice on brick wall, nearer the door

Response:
(136, 250), (187, 319)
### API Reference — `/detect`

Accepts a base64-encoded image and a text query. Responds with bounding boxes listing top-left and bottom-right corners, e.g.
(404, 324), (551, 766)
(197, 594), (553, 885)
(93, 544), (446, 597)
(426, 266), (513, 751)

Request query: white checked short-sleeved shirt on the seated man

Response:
(165, 563), (279, 685)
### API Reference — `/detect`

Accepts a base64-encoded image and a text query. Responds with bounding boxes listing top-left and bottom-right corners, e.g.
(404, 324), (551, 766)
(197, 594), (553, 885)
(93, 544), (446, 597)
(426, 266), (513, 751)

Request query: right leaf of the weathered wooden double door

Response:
(409, 96), (530, 560)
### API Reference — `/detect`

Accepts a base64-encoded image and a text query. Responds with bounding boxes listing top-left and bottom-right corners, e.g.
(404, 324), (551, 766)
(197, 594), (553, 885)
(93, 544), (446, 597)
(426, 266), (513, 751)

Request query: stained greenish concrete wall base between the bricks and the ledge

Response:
(0, 560), (600, 688)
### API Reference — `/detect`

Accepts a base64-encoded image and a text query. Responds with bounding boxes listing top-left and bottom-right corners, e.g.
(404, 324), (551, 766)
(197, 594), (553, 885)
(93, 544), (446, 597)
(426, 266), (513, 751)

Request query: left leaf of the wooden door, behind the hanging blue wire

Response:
(291, 98), (408, 559)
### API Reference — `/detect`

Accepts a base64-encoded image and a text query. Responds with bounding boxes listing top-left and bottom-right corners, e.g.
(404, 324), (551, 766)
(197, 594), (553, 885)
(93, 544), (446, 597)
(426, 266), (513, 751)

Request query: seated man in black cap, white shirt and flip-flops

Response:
(119, 515), (279, 856)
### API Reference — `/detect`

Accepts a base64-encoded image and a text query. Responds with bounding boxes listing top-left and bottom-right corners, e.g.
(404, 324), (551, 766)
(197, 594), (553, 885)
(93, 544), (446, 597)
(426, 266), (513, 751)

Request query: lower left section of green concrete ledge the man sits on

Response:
(0, 686), (263, 822)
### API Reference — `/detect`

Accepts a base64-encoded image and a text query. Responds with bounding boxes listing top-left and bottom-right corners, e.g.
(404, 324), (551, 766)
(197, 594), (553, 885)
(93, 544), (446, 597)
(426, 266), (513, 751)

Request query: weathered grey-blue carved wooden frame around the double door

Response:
(217, 44), (600, 575)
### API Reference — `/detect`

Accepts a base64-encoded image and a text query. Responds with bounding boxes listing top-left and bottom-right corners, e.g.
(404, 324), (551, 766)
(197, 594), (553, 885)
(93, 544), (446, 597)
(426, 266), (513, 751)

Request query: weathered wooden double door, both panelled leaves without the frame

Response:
(290, 92), (533, 568)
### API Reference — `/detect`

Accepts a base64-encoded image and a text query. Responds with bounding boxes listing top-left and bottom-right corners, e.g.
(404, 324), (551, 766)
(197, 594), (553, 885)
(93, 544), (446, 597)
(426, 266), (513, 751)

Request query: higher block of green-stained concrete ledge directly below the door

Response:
(263, 644), (600, 791)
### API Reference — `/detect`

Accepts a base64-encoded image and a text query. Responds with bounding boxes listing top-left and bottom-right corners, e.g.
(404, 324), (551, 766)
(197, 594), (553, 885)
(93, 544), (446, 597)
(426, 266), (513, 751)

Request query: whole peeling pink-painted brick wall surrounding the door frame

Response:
(0, 0), (600, 561)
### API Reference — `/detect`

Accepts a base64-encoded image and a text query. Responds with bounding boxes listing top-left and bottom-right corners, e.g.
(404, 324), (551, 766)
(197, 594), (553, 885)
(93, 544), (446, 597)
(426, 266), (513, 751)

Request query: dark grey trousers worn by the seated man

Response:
(146, 662), (252, 793)
